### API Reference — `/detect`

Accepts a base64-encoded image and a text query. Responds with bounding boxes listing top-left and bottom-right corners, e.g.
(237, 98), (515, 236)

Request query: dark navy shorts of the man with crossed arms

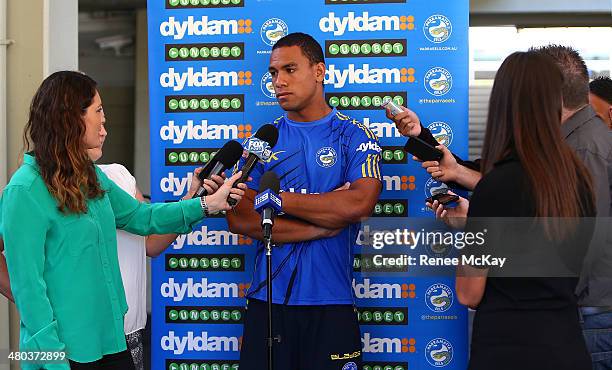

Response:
(240, 299), (362, 370)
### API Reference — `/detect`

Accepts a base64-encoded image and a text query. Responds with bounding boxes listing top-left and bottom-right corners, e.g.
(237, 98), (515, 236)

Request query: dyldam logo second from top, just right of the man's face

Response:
(325, 64), (415, 88)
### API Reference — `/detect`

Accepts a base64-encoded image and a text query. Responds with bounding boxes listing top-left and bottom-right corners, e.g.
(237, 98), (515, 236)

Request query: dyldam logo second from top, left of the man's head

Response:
(159, 67), (253, 91)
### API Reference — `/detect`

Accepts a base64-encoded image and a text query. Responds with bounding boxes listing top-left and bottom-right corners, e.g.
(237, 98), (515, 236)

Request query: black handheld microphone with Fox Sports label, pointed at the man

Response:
(227, 124), (278, 207)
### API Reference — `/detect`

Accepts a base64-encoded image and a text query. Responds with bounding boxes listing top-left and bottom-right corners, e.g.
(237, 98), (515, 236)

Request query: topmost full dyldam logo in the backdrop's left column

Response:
(159, 15), (253, 40)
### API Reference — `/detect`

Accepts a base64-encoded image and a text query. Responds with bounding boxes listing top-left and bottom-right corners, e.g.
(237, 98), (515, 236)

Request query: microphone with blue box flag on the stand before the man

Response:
(253, 171), (282, 240)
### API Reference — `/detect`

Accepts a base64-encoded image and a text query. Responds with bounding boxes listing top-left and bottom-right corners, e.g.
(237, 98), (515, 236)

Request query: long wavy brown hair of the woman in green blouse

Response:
(24, 71), (104, 213)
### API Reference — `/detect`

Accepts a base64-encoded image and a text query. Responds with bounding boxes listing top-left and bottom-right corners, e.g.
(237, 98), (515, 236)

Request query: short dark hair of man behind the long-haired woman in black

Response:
(530, 45), (589, 110)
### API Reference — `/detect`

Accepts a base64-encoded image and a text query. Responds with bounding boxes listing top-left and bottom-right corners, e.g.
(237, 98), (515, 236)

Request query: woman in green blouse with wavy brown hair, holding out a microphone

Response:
(0, 71), (244, 369)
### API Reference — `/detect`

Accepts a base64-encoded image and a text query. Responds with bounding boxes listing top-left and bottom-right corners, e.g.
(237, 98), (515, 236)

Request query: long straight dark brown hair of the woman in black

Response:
(481, 51), (593, 237)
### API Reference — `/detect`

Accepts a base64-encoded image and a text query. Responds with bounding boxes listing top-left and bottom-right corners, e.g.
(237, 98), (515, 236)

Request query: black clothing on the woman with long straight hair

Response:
(468, 158), (595, 370)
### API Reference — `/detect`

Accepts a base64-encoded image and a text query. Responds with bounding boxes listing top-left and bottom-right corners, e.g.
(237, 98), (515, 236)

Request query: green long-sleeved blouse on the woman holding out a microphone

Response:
(0, 154), (203, 369)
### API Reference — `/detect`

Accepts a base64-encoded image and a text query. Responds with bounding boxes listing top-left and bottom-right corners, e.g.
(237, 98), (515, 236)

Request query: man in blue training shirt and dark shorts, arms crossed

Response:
(227, 33), (382, 370)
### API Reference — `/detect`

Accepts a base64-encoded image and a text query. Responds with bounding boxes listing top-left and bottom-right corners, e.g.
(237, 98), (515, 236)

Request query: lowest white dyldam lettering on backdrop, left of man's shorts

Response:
(160, 331), (242, 355)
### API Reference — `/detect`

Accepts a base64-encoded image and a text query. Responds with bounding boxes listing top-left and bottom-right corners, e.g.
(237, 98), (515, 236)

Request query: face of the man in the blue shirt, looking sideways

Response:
(268, 46), (325, 112)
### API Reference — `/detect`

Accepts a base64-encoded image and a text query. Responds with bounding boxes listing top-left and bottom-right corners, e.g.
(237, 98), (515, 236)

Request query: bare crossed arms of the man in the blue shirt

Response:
(227, 178), (382, 243)
